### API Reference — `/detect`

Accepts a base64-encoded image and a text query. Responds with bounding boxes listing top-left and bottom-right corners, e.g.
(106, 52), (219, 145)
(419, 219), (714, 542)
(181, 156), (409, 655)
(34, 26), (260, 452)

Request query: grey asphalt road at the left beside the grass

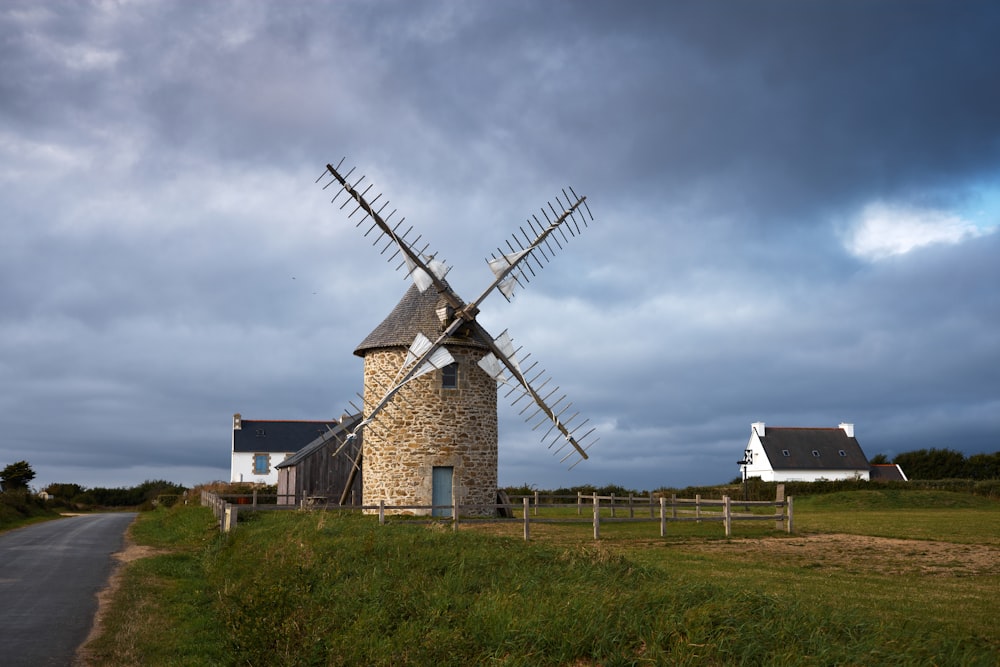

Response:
(0, 513), (135, 667)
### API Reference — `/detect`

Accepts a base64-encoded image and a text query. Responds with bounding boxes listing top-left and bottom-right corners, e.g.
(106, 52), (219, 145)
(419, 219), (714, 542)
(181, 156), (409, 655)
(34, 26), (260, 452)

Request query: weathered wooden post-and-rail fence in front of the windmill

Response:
(201, 489), (794, 541)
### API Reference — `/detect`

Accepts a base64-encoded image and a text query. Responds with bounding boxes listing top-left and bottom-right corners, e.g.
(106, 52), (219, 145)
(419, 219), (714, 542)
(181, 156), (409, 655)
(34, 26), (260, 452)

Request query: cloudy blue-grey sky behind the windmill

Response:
(0, 0), (1000, 489)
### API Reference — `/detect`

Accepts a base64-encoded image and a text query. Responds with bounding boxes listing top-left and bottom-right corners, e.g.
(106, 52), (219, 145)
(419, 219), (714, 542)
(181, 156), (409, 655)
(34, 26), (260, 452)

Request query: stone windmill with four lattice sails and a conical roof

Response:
(316, 160), (597, 513)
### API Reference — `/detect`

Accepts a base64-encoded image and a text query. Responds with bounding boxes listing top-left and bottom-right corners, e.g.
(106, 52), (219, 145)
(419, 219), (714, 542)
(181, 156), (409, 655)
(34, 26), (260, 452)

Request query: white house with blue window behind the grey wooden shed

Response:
(229, 412), (339, 484)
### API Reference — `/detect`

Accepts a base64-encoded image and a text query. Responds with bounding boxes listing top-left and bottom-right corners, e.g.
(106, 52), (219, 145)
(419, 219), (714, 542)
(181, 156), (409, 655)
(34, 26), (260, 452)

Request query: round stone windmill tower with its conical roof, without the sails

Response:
(354, 285), (497, 513)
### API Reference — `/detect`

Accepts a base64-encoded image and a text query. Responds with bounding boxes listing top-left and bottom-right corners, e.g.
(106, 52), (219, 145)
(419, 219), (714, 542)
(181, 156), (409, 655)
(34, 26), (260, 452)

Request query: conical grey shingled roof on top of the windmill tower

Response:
(354, 285), (485, 357)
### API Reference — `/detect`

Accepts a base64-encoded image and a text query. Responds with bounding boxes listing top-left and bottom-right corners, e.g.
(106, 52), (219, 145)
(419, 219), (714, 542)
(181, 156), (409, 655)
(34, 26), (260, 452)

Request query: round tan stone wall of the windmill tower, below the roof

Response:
(363, 347), (497, 516)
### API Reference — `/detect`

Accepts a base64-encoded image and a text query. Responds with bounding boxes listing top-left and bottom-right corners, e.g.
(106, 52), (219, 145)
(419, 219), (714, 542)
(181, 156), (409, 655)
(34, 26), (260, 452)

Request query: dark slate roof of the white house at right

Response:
(760, 426), (868, 470)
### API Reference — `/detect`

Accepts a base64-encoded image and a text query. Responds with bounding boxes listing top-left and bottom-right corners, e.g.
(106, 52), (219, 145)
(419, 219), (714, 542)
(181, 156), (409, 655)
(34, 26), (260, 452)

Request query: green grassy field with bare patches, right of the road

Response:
(84, 491), (1000, 665)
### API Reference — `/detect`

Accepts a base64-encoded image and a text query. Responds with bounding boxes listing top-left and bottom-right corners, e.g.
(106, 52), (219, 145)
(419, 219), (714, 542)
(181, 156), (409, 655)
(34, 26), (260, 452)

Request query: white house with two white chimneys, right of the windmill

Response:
(740, 422), (871, 482)
